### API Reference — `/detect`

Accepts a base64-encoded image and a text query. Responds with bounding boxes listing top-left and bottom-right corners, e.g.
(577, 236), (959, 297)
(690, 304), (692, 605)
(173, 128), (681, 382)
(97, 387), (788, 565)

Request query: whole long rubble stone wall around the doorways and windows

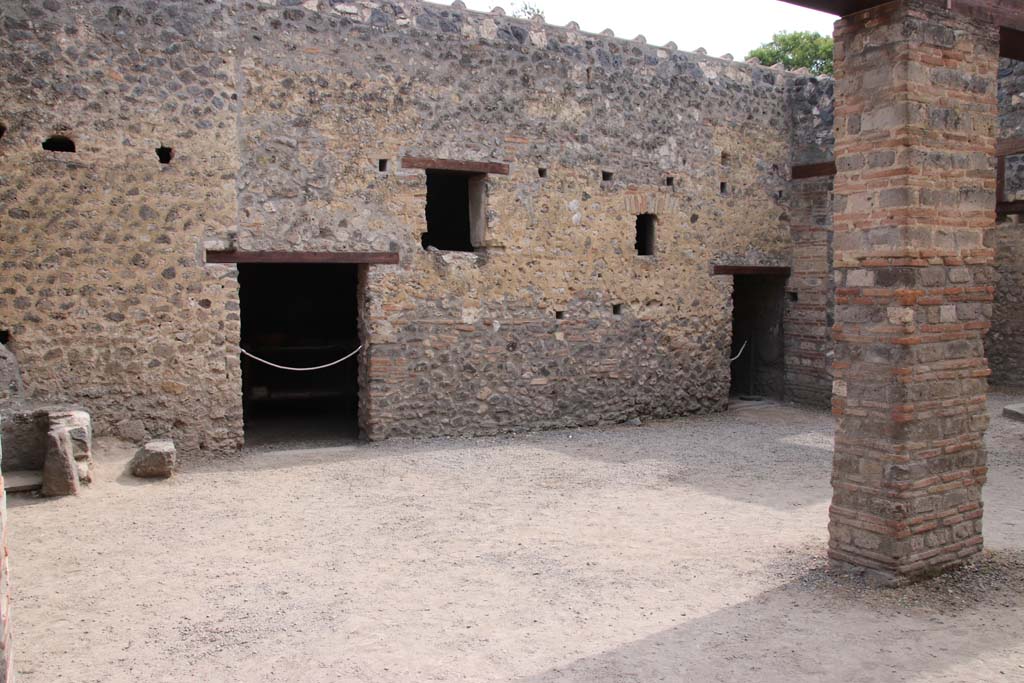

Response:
(0, 0), (806, 455)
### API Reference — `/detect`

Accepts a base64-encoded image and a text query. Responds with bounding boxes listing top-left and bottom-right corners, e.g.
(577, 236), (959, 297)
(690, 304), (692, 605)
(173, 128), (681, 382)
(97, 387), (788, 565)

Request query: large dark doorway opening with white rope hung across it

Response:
(238, 263), (360, 447)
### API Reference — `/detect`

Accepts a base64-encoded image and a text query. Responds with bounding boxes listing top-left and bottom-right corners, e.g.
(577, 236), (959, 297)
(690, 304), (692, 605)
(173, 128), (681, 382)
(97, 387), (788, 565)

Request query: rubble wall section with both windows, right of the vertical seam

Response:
(238, 3), (791, 438)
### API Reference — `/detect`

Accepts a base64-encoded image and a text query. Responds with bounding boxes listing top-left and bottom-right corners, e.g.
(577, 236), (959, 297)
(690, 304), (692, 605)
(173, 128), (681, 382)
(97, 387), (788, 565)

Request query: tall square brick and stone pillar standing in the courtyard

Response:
(828, 0), (998, 581)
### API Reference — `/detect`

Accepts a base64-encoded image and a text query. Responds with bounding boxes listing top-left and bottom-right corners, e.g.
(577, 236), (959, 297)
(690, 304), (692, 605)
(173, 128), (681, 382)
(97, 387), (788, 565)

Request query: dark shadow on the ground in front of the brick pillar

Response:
(517, 551), (1024, 683)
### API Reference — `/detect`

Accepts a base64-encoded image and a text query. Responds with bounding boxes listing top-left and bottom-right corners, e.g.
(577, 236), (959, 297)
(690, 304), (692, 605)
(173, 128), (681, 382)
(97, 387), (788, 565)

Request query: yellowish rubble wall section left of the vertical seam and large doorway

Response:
(0, 0), (242, 452)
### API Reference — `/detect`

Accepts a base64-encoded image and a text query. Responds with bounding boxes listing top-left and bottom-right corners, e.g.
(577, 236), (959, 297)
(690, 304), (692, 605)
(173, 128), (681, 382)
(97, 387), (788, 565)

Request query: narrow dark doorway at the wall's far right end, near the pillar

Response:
(729, 274), (785, 399)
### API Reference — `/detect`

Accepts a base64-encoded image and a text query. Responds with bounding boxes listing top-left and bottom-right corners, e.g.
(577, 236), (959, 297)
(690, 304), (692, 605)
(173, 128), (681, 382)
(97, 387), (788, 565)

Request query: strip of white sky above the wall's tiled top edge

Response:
(460, 0), (836, 59)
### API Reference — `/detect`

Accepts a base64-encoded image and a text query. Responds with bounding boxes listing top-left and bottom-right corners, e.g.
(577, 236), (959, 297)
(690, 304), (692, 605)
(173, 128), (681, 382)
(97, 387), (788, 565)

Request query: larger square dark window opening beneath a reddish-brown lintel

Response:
(422, 171), (487, 252)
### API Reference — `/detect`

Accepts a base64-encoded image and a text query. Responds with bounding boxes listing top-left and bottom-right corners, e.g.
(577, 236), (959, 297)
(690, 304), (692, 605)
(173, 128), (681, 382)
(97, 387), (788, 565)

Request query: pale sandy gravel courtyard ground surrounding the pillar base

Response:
(9, 394), (1024, 683)
